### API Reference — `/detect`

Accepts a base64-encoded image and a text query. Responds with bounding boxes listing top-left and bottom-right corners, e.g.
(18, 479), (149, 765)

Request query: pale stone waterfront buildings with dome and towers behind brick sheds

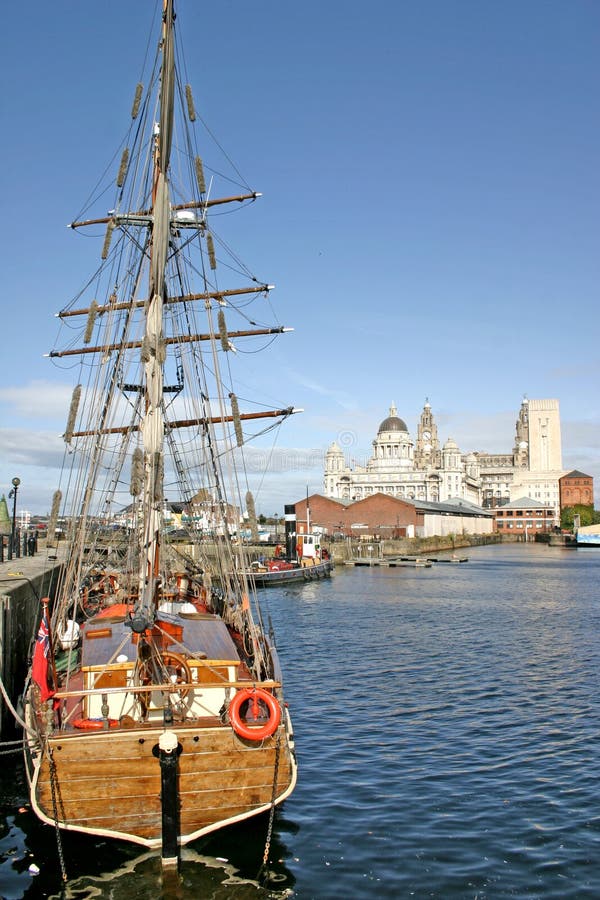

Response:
(324, 399), (563, 524)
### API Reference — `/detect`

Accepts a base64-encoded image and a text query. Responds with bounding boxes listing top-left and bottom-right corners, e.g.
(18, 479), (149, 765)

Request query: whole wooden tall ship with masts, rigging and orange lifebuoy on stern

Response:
(24, 0), (299, 865)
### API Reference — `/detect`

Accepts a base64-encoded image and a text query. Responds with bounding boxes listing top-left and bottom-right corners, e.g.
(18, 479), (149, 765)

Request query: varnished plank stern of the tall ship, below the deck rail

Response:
(29, 725), (296, 848)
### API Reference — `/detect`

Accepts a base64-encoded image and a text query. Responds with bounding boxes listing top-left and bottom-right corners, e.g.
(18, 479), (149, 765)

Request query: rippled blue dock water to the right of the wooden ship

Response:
(272, 547), (600, 898)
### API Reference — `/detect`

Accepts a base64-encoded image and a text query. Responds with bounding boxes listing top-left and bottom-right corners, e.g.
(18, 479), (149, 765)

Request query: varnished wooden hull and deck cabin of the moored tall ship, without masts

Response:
(27, 604), (296, 848)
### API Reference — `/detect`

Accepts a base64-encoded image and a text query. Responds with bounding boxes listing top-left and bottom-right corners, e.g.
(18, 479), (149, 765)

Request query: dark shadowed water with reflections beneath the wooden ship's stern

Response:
(0, 757), (296, 900)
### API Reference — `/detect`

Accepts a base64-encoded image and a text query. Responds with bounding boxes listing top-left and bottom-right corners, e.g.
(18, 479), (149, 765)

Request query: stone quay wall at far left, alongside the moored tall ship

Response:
(0, 552), (61, 737)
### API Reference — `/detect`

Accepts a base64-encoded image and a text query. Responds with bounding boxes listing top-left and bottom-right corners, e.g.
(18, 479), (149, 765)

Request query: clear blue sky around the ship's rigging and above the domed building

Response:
(0, 0), (600, 515)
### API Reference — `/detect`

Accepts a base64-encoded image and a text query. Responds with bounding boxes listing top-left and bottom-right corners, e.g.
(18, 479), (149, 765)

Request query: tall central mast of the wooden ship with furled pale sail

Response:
(138, 0), (175, 624)
